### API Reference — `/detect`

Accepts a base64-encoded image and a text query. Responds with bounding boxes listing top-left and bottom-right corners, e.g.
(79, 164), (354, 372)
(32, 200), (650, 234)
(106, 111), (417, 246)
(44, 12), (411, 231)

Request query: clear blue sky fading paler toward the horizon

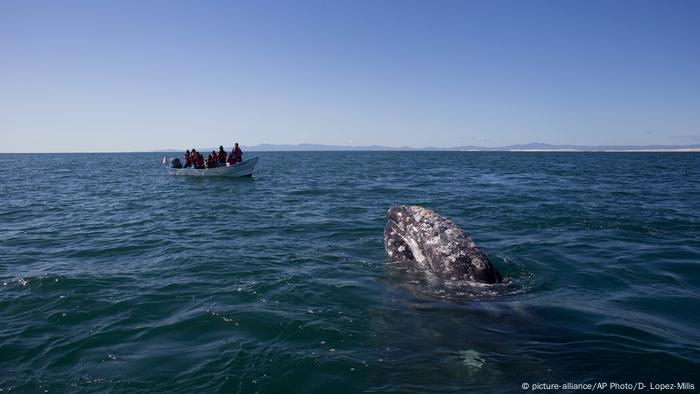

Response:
(0, 0), (700, 152)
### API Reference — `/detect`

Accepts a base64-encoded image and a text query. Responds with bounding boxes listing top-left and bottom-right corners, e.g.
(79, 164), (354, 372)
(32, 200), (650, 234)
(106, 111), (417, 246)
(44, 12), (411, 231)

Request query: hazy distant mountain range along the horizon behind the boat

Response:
(159, 142), (700, 152)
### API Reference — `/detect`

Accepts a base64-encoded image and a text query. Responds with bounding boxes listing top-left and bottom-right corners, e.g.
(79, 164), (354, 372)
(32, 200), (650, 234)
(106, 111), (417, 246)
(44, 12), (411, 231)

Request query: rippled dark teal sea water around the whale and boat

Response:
(0, 152), (700, 393)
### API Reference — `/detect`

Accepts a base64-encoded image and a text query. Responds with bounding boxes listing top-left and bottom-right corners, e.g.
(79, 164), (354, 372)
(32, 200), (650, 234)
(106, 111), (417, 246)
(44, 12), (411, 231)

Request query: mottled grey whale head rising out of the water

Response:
(384, 205), (503, 283)
